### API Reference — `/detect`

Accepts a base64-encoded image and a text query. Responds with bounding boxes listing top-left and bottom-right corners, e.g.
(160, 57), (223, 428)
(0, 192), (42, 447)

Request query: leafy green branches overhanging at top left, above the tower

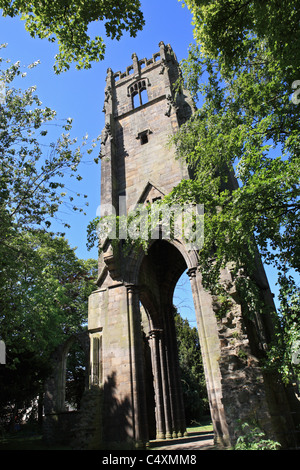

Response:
(0, 0), (144, 73)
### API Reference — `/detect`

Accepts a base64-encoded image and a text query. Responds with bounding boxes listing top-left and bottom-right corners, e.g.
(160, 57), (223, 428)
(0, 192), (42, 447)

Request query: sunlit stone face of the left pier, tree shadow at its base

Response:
(89, 285), (133, 442)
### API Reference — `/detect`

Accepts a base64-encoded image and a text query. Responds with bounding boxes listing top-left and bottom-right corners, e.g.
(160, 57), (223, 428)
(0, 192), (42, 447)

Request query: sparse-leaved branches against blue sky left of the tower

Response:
(0, 45), (97, 239)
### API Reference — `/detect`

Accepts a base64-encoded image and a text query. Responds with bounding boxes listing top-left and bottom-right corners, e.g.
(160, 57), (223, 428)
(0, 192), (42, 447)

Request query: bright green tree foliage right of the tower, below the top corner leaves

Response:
(172, 39), (300, 282)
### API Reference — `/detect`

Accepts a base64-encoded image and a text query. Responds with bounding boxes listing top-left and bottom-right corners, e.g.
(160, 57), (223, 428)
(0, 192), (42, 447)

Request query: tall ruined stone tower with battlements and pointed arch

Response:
(88, 42), (298, 445)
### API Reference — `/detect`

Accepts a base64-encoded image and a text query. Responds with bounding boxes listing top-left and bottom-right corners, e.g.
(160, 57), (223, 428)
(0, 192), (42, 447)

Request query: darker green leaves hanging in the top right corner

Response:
(179, 0), (300, 84)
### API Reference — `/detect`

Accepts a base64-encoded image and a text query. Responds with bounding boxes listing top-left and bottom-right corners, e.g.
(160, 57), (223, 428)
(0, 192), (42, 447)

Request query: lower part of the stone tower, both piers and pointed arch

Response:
(89, 235), (300, 447)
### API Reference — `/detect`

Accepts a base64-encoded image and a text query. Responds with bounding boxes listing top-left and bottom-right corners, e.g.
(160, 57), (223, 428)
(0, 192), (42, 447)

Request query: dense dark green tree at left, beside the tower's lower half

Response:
(0, 231), (97, 428)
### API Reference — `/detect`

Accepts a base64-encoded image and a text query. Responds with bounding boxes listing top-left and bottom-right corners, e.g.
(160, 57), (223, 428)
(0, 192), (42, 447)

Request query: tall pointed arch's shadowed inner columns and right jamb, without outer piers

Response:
(134, 240), (229, 445)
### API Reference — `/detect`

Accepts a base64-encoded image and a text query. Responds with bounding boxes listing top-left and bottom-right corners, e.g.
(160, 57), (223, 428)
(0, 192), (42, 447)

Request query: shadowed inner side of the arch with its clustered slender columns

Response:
(139, 241), (192, 439)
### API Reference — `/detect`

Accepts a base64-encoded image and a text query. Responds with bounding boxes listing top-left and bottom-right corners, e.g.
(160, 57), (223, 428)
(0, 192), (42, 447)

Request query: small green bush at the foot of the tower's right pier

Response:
(234, 423), (281, 450)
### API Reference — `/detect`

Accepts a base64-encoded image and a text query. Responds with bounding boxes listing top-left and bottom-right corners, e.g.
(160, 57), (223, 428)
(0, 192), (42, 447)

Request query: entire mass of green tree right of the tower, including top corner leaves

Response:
(167, 0), (300, 375)
